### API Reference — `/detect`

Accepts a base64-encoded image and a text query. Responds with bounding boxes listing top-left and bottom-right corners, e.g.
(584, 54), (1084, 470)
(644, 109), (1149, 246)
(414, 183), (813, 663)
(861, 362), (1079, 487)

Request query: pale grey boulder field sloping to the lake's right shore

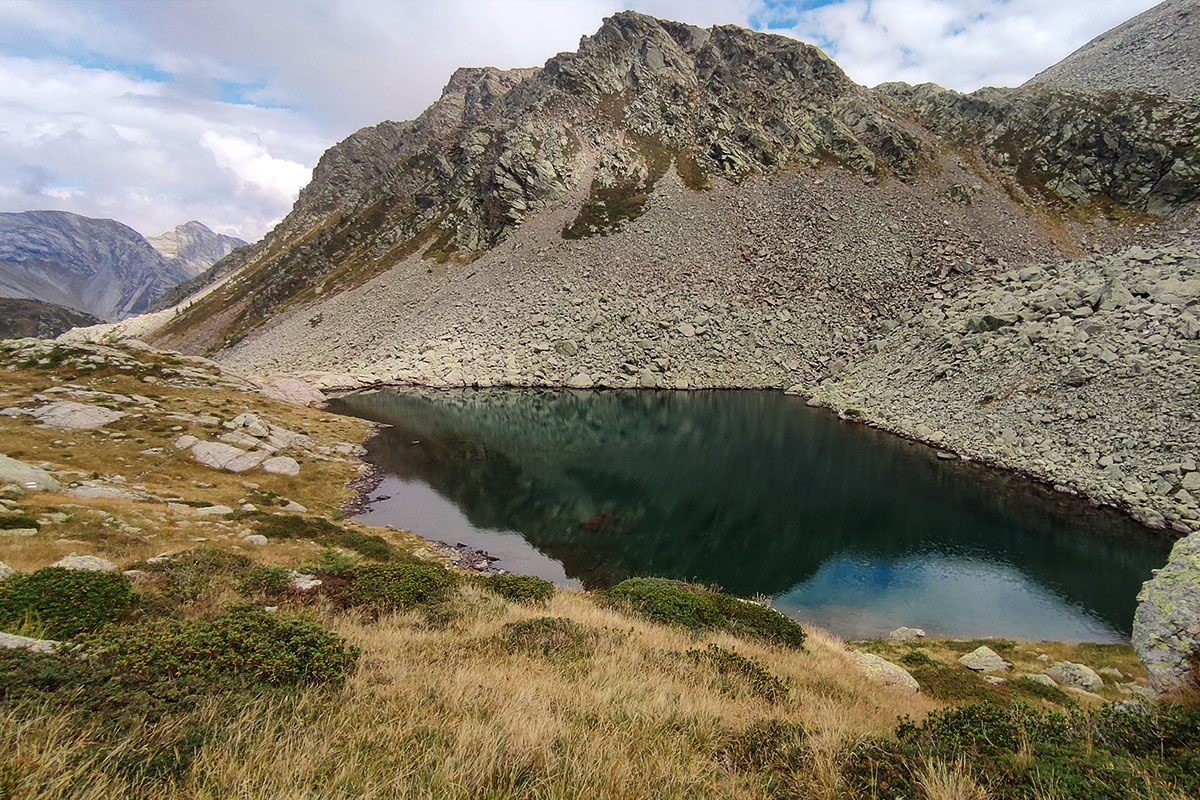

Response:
(812, 240), (1200, 533)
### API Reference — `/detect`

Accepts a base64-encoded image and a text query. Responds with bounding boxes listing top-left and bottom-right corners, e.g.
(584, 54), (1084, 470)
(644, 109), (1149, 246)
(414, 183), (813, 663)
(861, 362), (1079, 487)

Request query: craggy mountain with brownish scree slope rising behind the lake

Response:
(150, 12), (1200, 362)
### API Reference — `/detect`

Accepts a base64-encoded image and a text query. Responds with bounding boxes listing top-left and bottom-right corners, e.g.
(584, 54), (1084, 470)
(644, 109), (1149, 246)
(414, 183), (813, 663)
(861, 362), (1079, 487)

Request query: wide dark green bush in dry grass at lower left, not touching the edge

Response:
(84, 606), (359, 688)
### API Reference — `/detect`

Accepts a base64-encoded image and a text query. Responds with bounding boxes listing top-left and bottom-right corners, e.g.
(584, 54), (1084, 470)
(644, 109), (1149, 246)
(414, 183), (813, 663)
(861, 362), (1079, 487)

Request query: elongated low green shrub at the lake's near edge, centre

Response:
(605, 578), (804, 648)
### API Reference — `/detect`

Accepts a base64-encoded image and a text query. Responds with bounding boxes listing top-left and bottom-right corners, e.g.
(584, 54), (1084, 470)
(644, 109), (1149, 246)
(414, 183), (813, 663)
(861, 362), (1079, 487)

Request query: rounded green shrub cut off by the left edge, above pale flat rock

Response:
(0, 566), (133, 639)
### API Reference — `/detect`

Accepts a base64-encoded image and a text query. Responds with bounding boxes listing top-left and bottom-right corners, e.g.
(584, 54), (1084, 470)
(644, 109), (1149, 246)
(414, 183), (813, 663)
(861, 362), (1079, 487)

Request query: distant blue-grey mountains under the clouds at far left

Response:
(0, 211), (245, 320)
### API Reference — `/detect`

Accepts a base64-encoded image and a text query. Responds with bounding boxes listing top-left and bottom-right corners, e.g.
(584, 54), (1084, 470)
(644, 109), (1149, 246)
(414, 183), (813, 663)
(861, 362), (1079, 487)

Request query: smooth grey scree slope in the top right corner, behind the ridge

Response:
(1025, 0), (1200, 101)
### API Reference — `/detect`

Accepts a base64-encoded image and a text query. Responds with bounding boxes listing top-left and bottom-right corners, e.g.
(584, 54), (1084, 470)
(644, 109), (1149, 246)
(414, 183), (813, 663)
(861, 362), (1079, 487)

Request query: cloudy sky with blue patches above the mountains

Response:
(0, 0), (1154, 239)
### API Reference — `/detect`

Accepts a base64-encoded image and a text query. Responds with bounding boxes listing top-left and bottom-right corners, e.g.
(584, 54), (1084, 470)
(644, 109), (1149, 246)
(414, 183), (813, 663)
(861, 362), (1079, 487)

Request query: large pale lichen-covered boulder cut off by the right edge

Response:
(1133, 533), (1200, 692)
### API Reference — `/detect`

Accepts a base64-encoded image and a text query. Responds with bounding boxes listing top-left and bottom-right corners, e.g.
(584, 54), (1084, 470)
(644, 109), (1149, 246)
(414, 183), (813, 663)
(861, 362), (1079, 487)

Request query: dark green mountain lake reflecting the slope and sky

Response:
(332, 390), (1170, 642)
